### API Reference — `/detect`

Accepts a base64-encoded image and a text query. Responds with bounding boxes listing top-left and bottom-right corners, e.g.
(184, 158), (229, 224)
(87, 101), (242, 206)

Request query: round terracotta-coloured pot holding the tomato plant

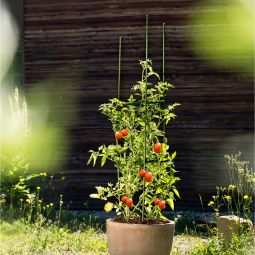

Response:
(106, 219), (175, 255)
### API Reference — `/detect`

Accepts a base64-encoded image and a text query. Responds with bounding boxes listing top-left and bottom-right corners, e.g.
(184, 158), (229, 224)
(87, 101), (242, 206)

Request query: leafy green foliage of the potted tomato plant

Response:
(88, 60), (180, 218)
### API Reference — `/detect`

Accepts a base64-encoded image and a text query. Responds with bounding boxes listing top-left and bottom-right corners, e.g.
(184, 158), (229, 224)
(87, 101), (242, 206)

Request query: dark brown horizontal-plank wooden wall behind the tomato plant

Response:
(24, 0), (254, 210)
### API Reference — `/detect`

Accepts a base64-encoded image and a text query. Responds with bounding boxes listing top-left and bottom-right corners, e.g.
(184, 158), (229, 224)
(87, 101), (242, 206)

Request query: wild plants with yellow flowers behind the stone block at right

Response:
(208, 152), (255, 219)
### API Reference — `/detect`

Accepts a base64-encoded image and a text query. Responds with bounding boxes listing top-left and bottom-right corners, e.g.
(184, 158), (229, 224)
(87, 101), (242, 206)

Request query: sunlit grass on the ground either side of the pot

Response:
(0, 218), (254, 255)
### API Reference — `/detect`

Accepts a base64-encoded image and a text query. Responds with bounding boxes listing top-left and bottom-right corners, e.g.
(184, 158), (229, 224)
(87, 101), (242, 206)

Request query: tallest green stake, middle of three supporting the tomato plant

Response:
(142, 15), (149, 222)
